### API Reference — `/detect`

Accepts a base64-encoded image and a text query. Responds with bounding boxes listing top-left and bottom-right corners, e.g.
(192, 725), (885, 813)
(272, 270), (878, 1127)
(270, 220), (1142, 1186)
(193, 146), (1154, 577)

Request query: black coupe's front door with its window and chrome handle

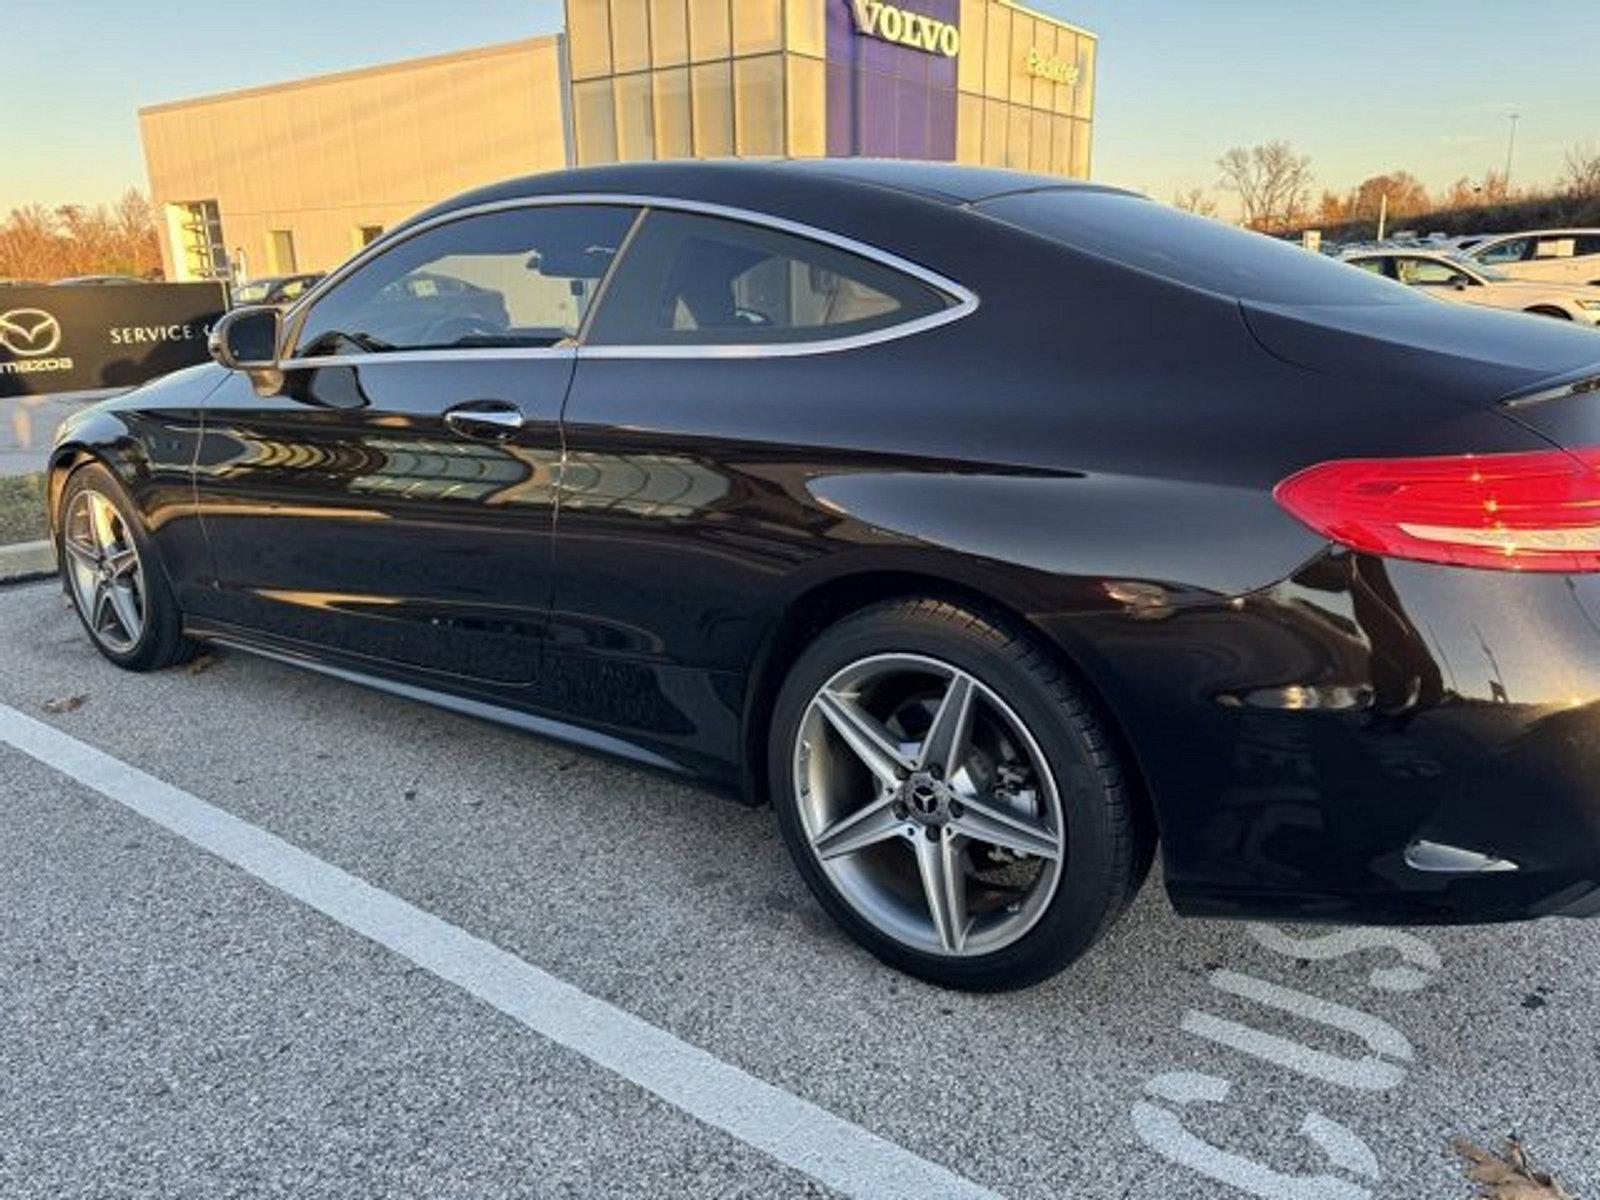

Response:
(195, 203), (637, 688)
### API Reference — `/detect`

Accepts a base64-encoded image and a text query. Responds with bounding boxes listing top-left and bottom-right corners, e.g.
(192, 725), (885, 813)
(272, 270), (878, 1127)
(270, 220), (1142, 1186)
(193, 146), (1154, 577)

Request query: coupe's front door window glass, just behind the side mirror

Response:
(294, 205), (637, 358)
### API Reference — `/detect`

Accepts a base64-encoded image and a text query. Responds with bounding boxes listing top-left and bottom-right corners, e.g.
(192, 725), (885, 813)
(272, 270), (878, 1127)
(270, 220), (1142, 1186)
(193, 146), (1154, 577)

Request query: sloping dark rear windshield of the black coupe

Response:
(979, 189), (1430, 304)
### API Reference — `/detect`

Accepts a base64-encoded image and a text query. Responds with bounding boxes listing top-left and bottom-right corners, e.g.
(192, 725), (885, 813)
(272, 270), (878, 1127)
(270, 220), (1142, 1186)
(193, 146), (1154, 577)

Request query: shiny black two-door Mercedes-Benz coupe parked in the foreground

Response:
(50, 162), (1600, 989)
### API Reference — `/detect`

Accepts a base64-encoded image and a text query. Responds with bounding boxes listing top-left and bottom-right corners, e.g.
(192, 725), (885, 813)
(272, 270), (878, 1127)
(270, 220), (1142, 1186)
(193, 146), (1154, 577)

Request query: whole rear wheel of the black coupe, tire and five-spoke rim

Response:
(770, 600), (1150, 989)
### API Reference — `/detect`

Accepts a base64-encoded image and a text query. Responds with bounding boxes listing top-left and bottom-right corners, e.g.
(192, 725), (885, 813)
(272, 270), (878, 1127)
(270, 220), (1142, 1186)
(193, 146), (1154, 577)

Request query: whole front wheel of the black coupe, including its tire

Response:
(58, 462), (197, 670)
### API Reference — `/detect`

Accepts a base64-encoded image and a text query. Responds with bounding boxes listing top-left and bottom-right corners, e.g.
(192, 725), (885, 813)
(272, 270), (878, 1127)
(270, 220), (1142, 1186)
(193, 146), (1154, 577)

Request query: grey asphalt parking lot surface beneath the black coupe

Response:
(0, 584), (1600, 1200)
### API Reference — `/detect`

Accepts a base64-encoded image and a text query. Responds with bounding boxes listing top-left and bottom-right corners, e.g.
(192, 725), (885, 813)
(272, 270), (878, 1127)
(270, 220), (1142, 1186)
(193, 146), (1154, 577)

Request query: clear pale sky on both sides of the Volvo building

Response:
(0, 0), (1600, 213)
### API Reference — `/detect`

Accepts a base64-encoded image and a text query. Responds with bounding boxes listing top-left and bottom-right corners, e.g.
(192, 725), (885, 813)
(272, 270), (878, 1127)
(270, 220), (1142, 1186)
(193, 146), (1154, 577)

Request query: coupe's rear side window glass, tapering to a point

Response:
(587, 211), (955, 346)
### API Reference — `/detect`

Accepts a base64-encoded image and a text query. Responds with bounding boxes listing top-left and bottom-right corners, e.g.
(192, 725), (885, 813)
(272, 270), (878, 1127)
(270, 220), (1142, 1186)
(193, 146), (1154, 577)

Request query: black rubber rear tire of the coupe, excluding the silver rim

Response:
(768, 598), (1154, 990)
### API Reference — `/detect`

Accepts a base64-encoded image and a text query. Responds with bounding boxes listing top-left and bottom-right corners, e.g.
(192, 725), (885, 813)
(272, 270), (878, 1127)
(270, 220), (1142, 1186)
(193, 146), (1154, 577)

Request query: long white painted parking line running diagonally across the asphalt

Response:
(0, 704), (997, 1200)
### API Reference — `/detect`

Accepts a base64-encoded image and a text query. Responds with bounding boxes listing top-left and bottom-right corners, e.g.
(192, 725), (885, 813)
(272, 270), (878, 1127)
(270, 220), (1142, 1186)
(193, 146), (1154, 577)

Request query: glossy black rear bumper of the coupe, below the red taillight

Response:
(1058, 552), (1600, 925)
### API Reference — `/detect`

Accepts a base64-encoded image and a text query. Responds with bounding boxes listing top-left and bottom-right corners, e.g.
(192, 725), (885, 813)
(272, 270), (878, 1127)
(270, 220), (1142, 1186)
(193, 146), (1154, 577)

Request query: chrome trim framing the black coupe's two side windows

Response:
(280, 192), (979, 361)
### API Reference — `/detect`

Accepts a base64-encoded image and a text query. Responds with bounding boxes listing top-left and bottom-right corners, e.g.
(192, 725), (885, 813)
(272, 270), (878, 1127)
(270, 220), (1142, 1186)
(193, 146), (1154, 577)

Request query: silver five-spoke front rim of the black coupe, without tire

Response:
(61, 488), (146, 654)
